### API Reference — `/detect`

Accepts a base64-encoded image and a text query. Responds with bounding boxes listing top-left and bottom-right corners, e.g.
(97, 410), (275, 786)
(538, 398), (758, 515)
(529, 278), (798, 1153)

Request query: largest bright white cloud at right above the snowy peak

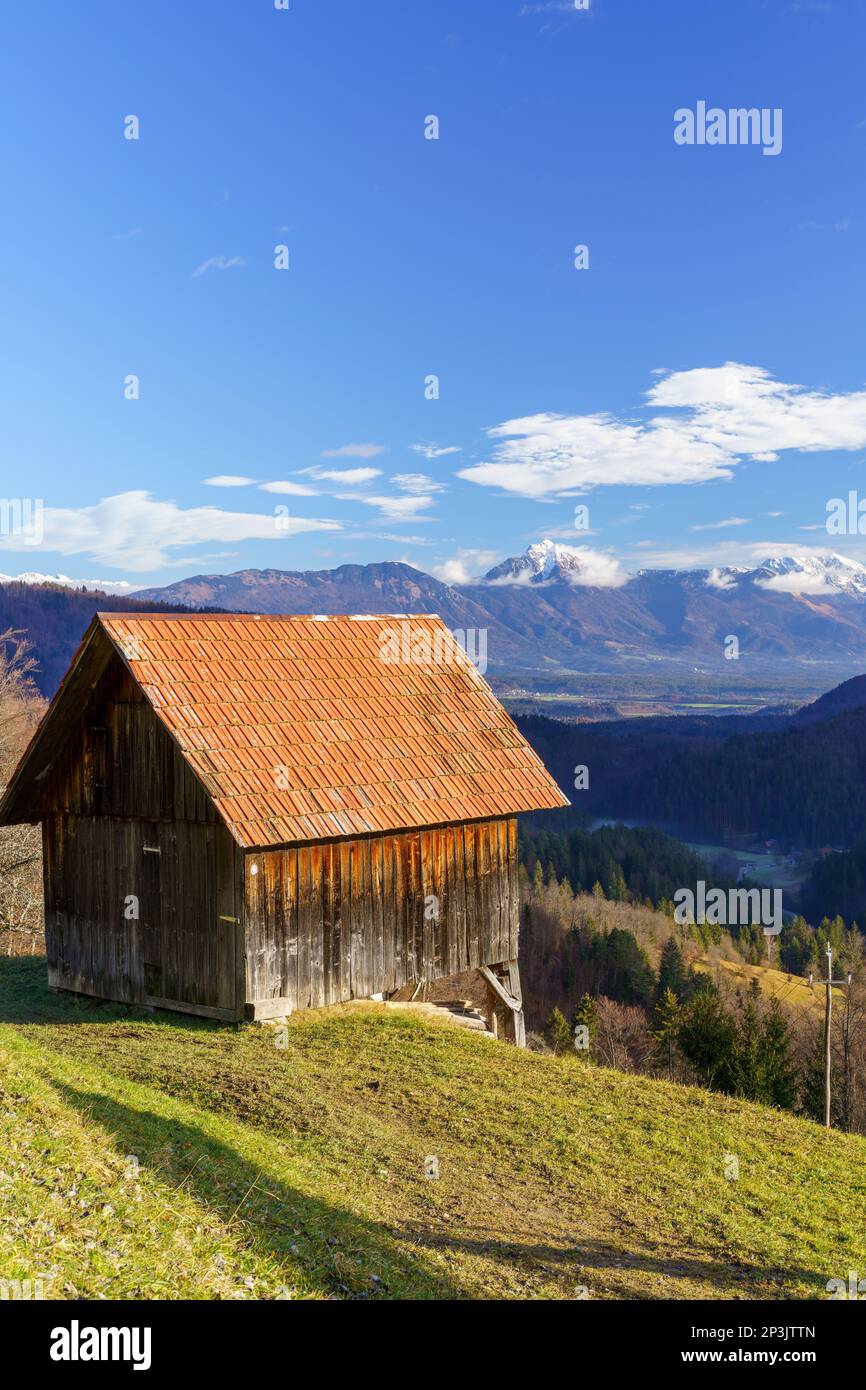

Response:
(457, 363), (866, 499)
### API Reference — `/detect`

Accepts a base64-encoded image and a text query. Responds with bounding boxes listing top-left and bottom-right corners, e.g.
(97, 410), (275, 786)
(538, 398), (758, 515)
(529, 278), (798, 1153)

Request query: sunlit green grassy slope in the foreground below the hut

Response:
(0, 959), (866, 1298)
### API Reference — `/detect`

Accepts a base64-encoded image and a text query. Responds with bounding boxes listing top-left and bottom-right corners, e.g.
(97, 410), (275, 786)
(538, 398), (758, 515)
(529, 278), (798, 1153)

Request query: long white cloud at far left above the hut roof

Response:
(0, 491), (342, 571)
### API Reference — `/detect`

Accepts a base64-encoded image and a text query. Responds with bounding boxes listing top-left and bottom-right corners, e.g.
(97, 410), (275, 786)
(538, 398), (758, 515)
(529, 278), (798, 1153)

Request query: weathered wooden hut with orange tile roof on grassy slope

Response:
(0, 613), (567, 1041)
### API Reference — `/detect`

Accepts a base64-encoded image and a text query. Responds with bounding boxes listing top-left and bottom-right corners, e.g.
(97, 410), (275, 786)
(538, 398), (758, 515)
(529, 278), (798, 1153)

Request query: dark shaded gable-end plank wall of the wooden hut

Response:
(42, 656), (245, 1017)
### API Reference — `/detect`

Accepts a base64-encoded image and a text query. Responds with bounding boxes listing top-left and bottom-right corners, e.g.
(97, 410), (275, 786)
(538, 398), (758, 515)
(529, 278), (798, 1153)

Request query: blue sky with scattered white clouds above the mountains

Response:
(0, 0), (866, 587)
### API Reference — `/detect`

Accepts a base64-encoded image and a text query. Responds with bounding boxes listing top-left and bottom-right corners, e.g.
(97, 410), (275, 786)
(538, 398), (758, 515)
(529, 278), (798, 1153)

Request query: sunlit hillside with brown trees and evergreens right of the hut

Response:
(520, 874), (866, 1133)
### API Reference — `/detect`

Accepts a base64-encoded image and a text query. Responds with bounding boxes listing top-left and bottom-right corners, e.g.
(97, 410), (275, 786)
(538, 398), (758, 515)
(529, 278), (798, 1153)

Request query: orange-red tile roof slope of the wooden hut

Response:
(99, 613), (569, 848)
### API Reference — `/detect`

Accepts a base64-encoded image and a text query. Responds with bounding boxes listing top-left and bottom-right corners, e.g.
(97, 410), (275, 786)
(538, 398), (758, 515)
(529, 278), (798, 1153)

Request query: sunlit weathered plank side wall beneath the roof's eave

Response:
(243, 817), (518, 1013)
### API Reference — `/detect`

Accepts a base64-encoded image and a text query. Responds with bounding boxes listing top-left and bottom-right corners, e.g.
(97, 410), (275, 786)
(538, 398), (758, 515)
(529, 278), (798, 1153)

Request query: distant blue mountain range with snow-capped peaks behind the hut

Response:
(8, 542), (866, 685)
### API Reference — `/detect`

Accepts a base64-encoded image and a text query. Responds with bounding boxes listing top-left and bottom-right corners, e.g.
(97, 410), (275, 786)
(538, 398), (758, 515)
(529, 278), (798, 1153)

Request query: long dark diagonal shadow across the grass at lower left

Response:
(51, 1080), (466, 1300)
